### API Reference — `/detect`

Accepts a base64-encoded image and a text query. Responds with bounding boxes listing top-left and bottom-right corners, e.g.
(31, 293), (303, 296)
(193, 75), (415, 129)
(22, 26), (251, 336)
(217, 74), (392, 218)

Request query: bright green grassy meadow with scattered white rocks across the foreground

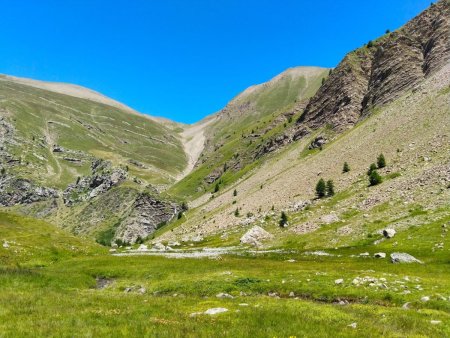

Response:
(0, 214), (450, 337)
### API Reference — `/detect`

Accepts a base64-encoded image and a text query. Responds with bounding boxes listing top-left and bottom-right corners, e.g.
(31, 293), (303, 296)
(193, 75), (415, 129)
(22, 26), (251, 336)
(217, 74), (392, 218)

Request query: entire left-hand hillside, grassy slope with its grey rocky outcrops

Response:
(0, 76), (187, 245)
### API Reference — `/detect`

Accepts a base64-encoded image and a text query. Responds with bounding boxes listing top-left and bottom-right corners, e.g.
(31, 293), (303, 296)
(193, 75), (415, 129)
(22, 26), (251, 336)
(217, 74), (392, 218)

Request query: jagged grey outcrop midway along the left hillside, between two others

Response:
(63, 160), (128, 206)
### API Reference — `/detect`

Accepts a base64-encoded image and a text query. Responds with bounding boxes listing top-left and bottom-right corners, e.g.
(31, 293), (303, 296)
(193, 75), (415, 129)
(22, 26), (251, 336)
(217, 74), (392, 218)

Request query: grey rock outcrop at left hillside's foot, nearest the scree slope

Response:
(115, 193), (181, 243)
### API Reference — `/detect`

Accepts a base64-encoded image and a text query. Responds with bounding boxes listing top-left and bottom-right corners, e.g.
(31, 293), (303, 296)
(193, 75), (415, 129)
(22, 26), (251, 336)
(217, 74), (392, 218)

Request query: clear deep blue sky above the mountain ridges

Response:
(0, 0), (430, 123)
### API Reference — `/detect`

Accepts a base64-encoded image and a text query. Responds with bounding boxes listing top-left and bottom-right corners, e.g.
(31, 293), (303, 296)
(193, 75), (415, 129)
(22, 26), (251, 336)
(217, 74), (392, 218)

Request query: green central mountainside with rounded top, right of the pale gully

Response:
(169, 67), (329, 198)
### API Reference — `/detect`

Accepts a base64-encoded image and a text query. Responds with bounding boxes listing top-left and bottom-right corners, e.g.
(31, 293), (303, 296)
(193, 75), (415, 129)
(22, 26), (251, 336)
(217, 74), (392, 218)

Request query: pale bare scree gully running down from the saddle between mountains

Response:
(177, 118), (216, 181)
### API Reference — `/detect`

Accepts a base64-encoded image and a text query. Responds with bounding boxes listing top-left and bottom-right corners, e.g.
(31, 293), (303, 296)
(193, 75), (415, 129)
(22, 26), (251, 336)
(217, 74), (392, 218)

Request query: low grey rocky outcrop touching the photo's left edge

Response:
(0, 175), (58, 207)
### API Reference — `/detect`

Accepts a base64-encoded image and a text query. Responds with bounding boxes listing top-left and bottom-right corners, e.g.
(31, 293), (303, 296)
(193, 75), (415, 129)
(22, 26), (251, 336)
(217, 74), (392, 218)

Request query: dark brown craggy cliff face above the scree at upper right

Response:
(298, 0), (450, 130)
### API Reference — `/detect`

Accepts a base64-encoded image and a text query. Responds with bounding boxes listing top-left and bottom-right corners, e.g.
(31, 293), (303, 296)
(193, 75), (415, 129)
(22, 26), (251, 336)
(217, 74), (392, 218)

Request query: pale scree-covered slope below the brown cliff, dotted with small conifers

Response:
(157, 61), (450, 247)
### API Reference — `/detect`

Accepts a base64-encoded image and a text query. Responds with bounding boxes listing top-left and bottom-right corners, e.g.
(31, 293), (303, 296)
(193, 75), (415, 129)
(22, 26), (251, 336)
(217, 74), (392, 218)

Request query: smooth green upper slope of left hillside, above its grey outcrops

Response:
(0, 77), (186, 188)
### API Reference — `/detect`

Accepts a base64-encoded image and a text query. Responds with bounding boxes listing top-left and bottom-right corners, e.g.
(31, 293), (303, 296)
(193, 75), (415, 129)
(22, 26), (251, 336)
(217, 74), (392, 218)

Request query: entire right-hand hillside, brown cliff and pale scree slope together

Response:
(156, 1), (450, 248)
